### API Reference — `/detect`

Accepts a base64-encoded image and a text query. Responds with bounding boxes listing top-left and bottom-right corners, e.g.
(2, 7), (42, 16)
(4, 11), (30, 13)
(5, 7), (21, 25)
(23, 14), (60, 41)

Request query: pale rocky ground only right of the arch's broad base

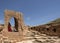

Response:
(17, 31), (60, 43)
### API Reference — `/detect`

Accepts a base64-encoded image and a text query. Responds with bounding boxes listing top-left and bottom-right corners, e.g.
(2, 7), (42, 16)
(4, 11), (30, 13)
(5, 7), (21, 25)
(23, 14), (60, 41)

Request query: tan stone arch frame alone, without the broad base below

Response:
(5, 10), (24, 31)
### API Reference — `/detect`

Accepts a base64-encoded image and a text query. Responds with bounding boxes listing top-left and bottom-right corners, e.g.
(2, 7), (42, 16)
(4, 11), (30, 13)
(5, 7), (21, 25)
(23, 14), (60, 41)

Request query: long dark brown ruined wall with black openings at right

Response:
(30, 23), (60, 36)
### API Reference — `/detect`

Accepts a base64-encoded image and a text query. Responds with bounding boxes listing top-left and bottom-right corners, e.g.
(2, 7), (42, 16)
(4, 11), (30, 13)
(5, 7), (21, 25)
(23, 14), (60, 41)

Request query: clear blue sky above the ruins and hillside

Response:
(0, 0), (60, 26)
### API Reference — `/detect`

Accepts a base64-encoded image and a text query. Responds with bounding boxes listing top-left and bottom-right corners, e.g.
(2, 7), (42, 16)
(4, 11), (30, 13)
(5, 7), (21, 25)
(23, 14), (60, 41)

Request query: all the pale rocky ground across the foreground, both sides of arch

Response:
(0, 30), (60, 43)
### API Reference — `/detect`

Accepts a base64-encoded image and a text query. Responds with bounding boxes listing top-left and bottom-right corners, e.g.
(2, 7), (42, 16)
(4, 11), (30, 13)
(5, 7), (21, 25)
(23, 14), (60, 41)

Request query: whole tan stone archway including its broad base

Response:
(2, 10), (28, 41)
